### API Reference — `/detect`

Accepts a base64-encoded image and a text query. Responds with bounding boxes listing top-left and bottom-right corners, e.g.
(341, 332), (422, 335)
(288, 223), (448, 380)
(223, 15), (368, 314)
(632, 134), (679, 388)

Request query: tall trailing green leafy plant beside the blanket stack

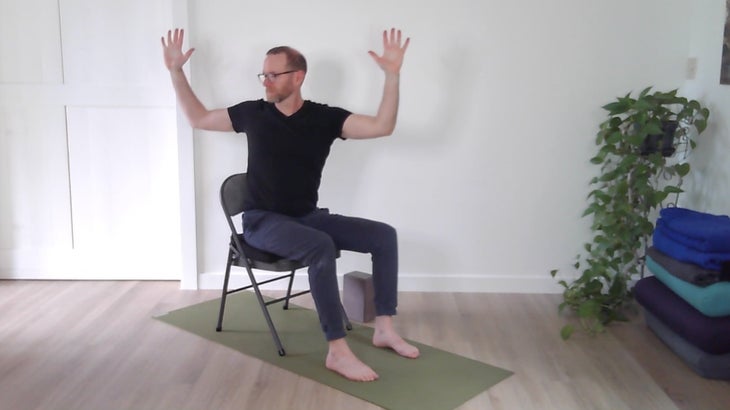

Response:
(550, 87), (710, 339)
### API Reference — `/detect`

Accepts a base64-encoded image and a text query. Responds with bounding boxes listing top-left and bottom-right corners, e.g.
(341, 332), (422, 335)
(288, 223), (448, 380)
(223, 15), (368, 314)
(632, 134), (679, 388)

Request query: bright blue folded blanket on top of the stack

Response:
(656, 207), (730, 252)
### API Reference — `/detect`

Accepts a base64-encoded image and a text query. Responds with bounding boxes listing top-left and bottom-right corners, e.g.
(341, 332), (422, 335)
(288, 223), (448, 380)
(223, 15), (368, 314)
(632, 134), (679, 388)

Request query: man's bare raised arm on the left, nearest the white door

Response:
(161, 29), (233, 131)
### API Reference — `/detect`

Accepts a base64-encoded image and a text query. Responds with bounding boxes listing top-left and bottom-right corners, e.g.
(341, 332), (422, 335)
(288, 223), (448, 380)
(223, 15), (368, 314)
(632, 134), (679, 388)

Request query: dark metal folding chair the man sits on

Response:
(216, 173), (352, 356)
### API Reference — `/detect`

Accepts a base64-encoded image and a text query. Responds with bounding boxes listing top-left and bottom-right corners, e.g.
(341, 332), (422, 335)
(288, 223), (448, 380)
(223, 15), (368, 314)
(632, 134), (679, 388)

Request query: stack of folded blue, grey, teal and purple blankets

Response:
(634, 207), (730, 380)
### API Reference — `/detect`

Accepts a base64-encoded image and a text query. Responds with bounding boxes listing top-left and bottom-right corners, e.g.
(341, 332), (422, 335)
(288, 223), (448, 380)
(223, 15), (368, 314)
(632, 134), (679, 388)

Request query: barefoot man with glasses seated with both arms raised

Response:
(161, 29), (419, 381)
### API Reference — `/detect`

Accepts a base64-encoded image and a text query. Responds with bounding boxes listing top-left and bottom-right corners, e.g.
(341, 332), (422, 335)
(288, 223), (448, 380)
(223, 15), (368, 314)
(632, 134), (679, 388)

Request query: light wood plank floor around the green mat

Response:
(0, 281), (730, 410)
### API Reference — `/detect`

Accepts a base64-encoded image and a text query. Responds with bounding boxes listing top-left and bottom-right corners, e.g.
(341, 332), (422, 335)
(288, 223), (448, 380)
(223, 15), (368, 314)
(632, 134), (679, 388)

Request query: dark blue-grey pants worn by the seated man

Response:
(243, 209), (398, 341)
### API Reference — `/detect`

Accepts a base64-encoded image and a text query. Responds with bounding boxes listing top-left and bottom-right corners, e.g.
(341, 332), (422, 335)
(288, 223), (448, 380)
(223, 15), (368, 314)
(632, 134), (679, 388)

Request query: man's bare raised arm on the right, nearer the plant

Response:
(342, 28), (410, 139)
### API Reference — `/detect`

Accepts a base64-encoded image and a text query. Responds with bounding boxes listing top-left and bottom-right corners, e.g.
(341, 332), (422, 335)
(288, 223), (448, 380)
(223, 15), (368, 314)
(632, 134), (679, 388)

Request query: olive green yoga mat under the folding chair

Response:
(156, 292), (512, 410)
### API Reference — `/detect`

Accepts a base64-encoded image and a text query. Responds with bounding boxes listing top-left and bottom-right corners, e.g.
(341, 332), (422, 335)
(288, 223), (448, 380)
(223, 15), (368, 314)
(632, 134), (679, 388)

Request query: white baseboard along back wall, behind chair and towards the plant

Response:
(193, 269), (563, 293)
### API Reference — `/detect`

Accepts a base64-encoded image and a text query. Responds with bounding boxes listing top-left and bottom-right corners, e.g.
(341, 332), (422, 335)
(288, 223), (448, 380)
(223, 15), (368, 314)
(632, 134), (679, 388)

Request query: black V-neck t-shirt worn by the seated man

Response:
(228, 100), (350, 216)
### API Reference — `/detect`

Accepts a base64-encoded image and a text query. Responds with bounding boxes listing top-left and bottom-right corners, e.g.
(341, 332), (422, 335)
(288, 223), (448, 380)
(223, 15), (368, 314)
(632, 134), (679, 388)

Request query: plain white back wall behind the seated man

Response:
(188, 0), (704, 292)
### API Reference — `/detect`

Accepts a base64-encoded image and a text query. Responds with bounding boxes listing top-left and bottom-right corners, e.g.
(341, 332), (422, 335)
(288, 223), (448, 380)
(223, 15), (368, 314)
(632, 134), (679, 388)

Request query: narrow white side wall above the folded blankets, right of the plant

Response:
(680, 0), (730, 215)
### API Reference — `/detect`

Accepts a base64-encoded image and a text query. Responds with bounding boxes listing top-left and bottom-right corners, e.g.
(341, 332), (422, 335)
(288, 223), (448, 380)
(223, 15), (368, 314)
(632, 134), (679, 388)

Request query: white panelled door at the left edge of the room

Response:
(0, 0), (181, 279)
